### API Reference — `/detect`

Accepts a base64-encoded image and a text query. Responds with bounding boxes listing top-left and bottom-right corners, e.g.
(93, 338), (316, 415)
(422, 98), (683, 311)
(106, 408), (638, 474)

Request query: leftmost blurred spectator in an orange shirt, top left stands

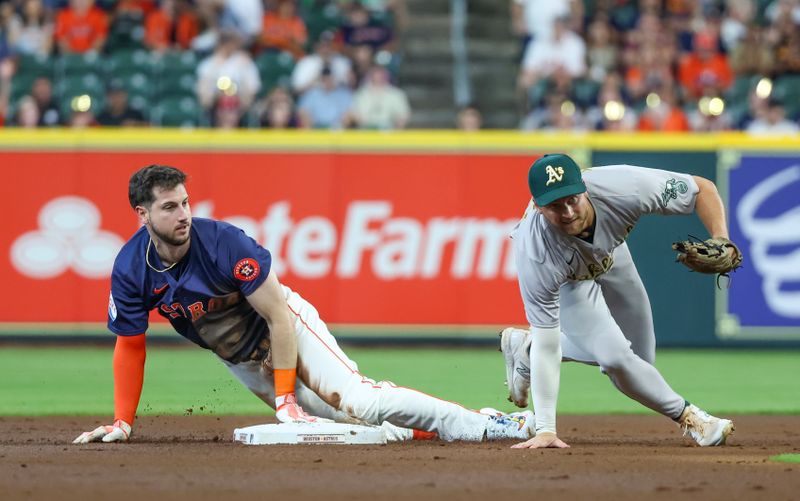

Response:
(144, 0), (200, 51)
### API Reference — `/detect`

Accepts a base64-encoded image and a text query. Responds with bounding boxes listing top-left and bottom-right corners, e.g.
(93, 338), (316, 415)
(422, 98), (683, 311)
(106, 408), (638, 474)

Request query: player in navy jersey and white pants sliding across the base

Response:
(74, 165), (533, 443)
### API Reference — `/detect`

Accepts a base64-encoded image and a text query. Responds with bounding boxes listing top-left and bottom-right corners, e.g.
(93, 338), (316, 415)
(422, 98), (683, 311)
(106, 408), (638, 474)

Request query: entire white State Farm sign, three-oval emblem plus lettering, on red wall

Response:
(11, 196), (518, 281)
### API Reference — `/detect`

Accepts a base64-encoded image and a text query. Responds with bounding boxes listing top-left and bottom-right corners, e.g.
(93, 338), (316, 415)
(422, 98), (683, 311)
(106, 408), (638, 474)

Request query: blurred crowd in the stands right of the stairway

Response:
(511, 0), (800, 134)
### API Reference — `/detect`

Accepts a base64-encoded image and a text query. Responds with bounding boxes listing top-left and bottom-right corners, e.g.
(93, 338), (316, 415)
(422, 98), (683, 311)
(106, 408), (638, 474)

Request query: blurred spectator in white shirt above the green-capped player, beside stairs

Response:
(519, 17), (586, 89)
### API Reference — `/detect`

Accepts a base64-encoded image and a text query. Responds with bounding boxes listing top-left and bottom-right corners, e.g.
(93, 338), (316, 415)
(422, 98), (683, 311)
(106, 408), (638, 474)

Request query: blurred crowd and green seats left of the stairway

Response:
(0, 0), (411, 129)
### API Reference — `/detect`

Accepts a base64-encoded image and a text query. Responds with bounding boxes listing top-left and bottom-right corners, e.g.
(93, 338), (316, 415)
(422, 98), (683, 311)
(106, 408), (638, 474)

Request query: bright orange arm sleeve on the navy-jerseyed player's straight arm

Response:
(114, 334), (146, 424)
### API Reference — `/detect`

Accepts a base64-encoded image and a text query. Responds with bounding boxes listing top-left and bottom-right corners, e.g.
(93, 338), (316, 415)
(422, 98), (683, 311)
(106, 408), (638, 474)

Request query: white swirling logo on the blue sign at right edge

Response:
(736, 165), (800, 318)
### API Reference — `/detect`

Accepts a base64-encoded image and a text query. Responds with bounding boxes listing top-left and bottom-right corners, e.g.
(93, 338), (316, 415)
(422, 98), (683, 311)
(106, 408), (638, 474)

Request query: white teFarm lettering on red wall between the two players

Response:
(192, 200), (518, 281)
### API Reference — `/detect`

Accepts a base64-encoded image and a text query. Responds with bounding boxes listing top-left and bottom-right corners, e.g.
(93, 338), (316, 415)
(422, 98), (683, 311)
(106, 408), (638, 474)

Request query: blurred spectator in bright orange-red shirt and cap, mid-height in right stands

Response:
(679, 32), (733, 97)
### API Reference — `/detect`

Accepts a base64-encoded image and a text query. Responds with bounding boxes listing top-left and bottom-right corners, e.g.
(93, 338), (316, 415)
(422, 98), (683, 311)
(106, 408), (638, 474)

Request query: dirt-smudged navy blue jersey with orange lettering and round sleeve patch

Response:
(108, 218), (272, 363)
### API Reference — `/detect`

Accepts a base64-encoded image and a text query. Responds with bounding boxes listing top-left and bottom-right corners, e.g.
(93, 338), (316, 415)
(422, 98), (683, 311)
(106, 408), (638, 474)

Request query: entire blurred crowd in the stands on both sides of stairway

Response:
(0, 0), (800, 134)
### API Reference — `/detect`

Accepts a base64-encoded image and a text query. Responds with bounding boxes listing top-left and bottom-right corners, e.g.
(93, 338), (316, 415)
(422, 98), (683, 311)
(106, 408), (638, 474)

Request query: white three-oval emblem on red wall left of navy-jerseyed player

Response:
(11, 196), (124, 280)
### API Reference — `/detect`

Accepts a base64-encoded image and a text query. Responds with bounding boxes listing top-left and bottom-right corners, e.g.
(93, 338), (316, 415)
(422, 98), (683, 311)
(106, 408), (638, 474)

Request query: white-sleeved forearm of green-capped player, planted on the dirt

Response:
(531, 327), (561, 433)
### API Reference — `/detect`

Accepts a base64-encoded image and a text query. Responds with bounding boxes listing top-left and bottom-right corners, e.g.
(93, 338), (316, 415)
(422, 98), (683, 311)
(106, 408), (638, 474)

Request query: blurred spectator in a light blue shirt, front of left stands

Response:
(297, 66), (353, 129)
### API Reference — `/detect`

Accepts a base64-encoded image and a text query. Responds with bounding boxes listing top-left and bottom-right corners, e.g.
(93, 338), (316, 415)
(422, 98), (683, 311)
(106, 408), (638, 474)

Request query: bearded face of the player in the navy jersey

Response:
(147, 184), (192, 246)
